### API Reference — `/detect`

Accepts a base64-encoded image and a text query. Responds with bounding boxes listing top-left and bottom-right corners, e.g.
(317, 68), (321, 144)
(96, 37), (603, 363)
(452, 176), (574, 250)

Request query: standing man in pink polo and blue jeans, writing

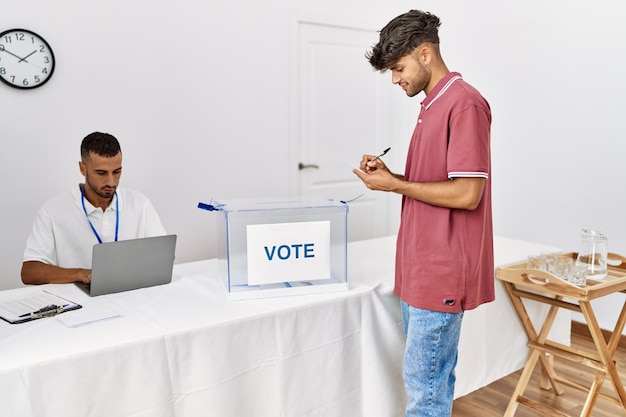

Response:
(354, 10), (495, 417)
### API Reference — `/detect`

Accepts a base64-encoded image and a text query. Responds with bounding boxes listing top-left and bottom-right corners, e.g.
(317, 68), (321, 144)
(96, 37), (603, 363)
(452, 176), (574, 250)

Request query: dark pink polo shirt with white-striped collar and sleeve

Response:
(395, 73), (495, 312)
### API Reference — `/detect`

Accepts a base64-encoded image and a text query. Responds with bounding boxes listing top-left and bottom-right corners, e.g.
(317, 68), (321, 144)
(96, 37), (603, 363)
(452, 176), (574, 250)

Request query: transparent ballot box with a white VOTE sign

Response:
(198, 198), (348, 300)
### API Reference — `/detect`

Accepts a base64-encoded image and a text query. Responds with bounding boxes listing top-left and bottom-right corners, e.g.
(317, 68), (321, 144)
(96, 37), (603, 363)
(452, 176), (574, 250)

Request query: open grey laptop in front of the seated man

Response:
(76, 235), (176, 297)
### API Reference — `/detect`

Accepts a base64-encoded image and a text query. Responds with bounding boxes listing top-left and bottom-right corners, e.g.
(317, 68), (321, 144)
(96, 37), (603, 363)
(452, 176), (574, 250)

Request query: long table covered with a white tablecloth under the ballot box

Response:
(0, 237), (569, 417)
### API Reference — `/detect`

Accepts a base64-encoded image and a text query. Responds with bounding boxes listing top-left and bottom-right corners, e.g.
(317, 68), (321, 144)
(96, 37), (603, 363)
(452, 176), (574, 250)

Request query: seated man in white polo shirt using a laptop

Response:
(22, 132), (166, 284)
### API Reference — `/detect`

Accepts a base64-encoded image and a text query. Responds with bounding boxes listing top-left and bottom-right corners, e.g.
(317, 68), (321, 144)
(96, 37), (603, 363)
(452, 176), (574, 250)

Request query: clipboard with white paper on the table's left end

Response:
(0, 290), (82, 324)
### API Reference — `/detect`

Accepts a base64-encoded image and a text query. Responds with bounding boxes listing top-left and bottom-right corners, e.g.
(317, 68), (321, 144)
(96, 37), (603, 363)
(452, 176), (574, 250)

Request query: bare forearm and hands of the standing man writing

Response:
(353, 156), (485, 210)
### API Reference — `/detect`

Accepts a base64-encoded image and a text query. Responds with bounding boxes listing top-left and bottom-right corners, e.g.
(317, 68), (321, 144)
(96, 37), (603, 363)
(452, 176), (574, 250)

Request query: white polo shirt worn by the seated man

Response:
(23, 187), (166, 268)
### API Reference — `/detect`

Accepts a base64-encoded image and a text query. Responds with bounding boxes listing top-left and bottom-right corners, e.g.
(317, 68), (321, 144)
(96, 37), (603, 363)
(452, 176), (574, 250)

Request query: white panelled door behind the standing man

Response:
(291, 17), (397, 241)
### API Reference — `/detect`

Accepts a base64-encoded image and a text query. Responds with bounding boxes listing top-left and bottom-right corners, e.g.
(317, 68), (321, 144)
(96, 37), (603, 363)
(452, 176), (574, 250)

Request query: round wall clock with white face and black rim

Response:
(0, 29), (54, 88)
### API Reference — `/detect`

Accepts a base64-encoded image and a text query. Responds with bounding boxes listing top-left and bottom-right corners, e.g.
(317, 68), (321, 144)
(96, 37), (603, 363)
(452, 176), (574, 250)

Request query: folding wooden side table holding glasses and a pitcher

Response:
(496, 253), (626, 417)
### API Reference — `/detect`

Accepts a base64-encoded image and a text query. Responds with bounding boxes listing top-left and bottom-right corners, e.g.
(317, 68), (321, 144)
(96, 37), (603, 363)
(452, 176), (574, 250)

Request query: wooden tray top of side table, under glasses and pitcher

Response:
(496, 252), (626, 301)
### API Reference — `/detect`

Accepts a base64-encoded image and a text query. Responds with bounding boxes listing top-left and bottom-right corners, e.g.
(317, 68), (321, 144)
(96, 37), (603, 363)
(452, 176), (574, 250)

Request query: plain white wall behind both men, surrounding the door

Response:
(0, 0), (626, 327)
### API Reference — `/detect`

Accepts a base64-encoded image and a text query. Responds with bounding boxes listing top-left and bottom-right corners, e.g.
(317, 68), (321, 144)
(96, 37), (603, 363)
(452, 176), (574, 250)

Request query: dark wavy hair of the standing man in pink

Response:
(366, 10), (441, 71)
